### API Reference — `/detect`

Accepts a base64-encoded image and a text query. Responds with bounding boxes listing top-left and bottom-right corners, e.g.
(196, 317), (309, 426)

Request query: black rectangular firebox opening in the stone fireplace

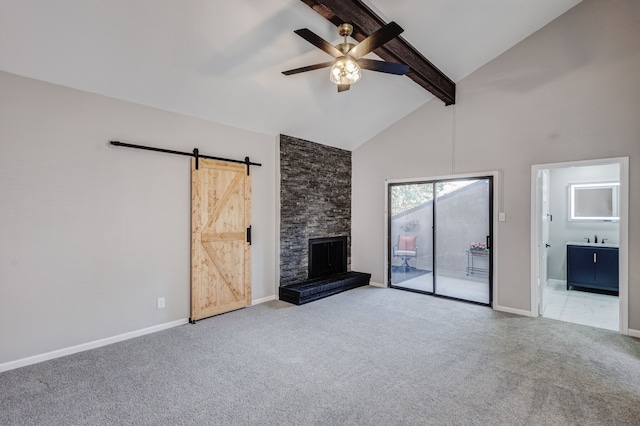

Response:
(309, 236), (347, 278)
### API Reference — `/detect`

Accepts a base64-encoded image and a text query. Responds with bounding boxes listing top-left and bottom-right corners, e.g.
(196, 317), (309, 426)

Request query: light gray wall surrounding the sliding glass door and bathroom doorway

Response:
(352, 0), (640, 322)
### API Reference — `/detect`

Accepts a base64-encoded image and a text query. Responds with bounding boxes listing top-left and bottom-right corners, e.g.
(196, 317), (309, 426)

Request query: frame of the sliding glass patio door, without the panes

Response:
(385, 172), (499, 307)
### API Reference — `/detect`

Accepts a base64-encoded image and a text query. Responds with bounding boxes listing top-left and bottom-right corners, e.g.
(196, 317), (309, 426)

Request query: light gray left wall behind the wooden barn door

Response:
(0, 72), (277, 364)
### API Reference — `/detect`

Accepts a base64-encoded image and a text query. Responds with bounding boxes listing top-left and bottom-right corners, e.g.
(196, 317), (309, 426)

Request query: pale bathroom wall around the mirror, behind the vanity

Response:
(547, 164), (620, 280)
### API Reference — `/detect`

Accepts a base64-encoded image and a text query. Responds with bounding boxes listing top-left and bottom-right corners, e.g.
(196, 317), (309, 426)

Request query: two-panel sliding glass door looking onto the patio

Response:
(389, 177), (493, 305)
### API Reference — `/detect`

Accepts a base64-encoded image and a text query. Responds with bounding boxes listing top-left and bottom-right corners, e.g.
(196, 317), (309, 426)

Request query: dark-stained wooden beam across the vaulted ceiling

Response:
(302, 0), (456, 105)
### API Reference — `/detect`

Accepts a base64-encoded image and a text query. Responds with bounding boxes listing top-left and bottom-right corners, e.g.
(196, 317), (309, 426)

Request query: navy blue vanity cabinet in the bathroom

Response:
(567, 245), (618, 292)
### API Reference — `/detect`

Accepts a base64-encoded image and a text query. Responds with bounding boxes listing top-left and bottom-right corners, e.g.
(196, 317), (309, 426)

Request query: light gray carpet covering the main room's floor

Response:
(0, 287), (640, 425)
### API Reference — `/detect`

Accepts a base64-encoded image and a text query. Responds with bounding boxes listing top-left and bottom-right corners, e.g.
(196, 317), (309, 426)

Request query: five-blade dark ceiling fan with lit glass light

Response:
(282, 22), (409, 92)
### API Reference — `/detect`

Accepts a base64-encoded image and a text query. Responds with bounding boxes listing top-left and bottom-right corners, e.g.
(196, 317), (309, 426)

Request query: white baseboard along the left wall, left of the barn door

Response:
(0, 318), (189, 373)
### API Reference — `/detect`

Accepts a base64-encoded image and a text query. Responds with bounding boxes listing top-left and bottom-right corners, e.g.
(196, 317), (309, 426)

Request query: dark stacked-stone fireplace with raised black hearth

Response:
(279, 135), (371, 305)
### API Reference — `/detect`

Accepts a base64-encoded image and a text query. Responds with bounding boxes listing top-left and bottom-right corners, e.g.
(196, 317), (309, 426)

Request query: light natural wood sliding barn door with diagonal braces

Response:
(191, 159), (251, 321)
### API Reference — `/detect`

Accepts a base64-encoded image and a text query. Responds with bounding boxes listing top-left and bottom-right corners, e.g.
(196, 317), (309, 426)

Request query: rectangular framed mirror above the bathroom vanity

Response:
(569, 182), (620, 222)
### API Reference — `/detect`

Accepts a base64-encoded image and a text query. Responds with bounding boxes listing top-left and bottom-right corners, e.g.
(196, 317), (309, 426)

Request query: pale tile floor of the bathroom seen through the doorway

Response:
(542, 280), (620, 331)
